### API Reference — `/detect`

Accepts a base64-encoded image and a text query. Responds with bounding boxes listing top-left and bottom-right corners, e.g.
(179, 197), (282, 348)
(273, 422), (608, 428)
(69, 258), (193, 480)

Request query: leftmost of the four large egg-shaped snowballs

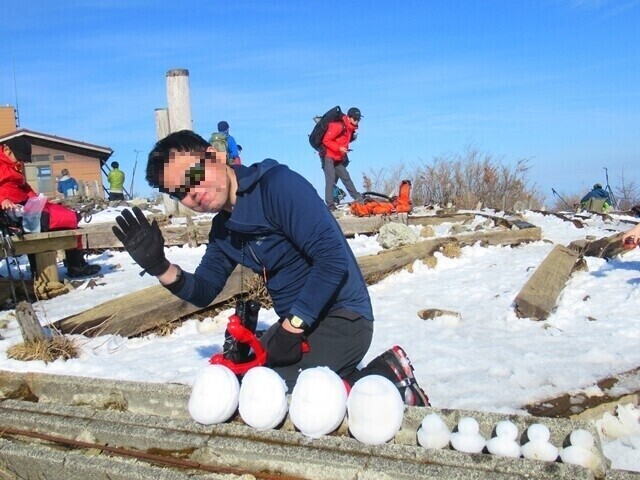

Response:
(188, 365), (240, 425)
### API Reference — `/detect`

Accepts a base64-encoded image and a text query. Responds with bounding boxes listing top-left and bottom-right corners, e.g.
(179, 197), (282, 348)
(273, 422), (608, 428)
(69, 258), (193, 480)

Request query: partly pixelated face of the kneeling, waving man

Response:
(162, 148), (230, 212)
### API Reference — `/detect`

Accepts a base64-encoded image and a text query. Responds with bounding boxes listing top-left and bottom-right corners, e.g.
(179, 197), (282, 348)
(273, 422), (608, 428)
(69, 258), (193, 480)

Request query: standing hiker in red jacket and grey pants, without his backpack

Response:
(322, 107), (362, 210)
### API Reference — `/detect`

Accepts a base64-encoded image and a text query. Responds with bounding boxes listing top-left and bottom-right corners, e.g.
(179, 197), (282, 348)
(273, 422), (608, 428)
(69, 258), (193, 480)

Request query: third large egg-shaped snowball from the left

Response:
(289, 367), (347, 438)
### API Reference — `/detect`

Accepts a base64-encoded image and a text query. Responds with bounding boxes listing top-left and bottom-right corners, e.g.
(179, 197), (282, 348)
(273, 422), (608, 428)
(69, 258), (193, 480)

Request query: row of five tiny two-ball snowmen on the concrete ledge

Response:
(418, 413), (600, 470)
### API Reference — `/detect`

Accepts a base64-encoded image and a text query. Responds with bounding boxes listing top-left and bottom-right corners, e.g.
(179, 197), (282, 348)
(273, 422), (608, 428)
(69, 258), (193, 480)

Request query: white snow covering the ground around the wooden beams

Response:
(0, 208), (640, 471)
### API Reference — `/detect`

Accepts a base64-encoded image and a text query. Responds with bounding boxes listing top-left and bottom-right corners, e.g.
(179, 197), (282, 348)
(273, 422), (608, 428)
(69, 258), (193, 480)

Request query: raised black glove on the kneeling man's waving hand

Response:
(112, 207), (171, 275)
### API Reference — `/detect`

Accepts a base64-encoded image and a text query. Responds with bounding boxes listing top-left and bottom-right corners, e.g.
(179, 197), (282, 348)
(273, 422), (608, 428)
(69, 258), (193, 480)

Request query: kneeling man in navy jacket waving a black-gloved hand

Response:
(113, 130), (428, 405)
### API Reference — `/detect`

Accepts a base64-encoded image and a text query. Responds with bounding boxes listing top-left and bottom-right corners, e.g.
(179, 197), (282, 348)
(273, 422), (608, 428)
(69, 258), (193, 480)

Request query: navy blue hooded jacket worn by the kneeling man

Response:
(177, 159), (373, 326)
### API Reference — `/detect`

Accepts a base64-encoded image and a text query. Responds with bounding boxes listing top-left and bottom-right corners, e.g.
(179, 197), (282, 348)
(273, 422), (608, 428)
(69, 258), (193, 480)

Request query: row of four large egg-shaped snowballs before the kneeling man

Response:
(188, 365), (404, 445)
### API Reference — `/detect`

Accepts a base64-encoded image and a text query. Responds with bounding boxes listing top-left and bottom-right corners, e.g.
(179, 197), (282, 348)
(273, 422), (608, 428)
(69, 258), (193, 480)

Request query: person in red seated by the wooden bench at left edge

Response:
(0, 137), (100, 277)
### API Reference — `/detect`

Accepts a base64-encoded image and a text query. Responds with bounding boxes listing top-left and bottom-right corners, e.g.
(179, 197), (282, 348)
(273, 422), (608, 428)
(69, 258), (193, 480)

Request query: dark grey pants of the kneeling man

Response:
(260, 312), (373, 393)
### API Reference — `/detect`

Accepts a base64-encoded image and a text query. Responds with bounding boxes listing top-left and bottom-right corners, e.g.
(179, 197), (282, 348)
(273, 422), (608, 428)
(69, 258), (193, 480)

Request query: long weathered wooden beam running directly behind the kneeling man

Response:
(54, 227), (542, 336)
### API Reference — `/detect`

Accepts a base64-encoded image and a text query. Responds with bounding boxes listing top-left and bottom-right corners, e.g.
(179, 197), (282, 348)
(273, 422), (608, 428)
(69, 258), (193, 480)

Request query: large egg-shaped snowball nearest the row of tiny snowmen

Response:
(347, 375), (404, 445)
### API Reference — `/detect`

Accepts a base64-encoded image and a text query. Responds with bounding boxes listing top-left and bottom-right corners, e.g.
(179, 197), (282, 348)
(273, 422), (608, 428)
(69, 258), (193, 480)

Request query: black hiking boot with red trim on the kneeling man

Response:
(360, 345), (430, 407)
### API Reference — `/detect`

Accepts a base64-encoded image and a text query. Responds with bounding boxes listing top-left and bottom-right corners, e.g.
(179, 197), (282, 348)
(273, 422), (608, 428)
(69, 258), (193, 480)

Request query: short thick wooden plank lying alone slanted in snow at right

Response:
(515, 245), (580, 320)
